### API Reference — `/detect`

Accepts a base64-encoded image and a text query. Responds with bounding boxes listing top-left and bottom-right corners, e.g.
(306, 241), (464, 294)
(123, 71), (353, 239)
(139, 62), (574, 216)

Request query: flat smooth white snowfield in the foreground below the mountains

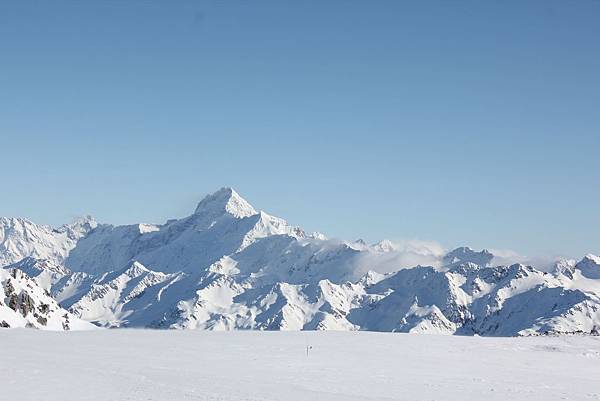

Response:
(0, 329), (600, 401)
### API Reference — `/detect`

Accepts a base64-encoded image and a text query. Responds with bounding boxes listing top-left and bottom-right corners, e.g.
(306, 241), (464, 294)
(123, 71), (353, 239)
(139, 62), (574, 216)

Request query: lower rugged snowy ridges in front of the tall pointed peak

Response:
(59, 252), (600, 336)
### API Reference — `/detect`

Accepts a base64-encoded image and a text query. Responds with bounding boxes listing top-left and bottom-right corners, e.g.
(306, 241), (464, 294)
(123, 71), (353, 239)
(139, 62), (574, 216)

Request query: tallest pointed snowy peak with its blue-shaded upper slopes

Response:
(65, 188), (305, 274)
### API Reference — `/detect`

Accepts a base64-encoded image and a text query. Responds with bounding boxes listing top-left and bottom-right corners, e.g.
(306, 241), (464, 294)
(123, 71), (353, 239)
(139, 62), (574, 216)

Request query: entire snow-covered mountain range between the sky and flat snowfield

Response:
(0, 188), (600, 336)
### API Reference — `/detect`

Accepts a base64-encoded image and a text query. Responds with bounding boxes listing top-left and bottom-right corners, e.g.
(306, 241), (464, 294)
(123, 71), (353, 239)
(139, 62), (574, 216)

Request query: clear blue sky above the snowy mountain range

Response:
(0, 0), (600, 256)
